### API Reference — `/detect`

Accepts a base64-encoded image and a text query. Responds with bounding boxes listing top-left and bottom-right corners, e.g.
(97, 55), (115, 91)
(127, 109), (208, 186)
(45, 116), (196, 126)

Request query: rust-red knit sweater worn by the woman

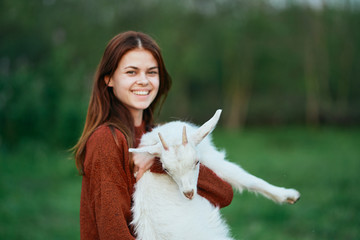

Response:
(80, 125), (233, 240)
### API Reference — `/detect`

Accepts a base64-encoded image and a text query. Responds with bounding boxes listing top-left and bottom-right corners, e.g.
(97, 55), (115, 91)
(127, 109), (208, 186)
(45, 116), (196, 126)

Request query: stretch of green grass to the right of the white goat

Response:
(215, 128), (360, 240)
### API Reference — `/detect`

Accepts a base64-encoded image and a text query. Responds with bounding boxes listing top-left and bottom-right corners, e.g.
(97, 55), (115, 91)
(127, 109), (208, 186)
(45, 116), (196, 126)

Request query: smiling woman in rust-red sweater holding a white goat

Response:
(74, 31), (233, 240)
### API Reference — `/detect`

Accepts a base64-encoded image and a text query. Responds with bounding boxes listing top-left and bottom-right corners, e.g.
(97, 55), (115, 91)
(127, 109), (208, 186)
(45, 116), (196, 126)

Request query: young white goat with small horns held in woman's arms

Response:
(129, 110), (300, 240)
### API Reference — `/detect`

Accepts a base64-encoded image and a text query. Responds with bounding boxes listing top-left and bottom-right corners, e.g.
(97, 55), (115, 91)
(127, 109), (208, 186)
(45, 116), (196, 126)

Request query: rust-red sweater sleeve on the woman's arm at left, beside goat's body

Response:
(81, 127), (135, 240)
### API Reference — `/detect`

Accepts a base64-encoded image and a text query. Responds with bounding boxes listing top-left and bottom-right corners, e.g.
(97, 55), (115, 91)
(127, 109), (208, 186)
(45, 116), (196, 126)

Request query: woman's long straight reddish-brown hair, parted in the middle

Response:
(73, 31), (171, 175)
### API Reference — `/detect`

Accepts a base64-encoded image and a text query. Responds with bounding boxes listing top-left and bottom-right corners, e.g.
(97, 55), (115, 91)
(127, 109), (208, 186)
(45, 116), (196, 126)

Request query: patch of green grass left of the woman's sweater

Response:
(0, 142), (81, 240)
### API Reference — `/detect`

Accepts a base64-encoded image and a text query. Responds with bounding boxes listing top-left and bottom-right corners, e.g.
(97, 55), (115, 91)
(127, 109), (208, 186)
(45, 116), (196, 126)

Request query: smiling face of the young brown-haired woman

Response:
(105, 48), (160, 118)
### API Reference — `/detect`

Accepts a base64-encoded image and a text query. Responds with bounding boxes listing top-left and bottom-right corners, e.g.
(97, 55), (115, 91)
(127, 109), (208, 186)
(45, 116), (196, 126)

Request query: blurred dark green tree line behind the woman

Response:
(0, 0), (360, 147)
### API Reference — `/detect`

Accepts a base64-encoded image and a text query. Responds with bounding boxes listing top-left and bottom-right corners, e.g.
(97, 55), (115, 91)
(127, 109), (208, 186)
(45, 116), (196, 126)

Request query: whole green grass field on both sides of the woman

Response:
(0, 127), (360, 240)
